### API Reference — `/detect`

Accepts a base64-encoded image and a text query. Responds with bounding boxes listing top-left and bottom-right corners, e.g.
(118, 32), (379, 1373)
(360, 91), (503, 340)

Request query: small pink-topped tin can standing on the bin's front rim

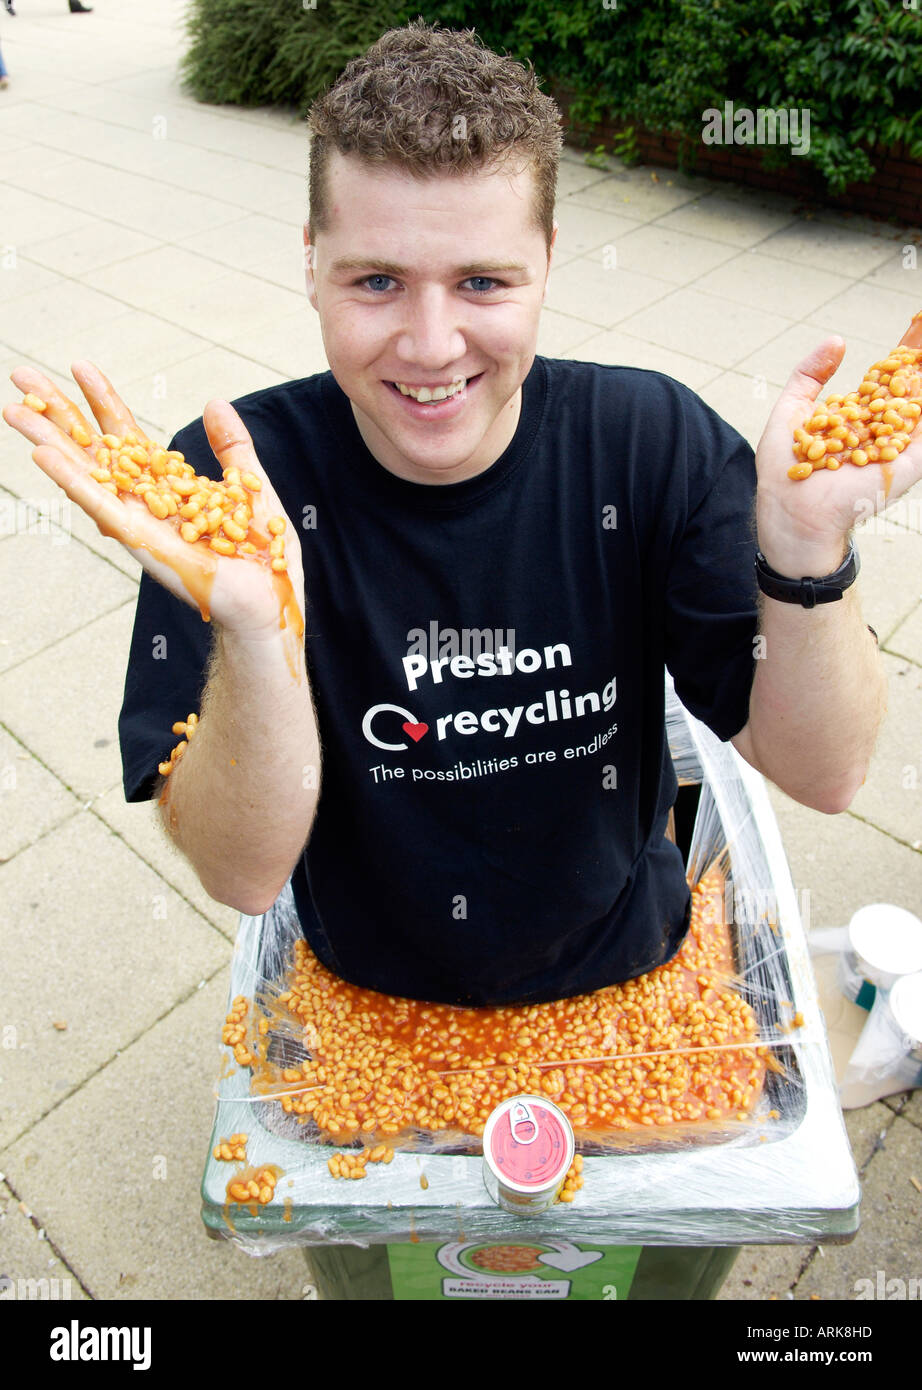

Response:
(484, 1095), (576, 1215)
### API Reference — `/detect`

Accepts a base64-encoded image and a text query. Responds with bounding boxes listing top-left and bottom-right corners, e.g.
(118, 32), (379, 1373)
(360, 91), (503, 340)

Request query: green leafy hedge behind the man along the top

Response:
(185, 0), (922, 193)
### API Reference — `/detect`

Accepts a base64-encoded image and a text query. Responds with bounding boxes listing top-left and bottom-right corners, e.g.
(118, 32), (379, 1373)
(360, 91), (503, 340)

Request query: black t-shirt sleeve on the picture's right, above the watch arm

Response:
(666, 392), (758, 741)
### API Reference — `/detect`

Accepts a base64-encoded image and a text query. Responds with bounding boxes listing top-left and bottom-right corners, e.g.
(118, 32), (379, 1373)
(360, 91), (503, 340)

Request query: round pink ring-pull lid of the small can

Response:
(484, 1095), (574, 1190)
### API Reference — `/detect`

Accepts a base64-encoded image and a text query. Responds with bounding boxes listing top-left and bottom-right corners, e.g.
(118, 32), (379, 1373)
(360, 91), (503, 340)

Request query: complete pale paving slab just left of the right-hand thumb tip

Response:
(619, 286), (791, 367)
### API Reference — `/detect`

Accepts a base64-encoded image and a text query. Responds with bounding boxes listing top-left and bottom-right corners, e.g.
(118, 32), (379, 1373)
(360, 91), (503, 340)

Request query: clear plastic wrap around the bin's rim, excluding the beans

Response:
(202, 681), (859, 1255)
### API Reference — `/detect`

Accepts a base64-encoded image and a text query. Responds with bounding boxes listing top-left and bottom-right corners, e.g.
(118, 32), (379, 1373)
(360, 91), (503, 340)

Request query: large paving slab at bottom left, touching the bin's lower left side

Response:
(0, 970), (307, 1302)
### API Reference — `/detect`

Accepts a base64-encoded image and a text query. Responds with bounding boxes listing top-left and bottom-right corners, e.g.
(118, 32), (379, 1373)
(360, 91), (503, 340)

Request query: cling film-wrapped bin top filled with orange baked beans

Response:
(203, 680), (858, 1255)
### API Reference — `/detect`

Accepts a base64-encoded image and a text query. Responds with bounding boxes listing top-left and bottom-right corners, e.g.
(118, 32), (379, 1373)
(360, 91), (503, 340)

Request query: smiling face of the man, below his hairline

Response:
(305, 152), (556, 482)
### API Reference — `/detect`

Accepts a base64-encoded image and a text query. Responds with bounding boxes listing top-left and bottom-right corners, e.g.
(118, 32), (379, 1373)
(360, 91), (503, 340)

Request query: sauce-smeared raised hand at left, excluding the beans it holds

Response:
(3, 363), (305, 641)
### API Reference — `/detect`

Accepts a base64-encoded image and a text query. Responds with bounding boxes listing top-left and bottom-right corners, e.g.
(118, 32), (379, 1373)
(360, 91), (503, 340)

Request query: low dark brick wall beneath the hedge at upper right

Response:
(551, 86), (922, 227)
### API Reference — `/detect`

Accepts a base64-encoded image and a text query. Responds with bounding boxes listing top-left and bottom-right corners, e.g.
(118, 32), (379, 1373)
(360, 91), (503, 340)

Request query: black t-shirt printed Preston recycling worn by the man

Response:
(120, 357), (757, 1005)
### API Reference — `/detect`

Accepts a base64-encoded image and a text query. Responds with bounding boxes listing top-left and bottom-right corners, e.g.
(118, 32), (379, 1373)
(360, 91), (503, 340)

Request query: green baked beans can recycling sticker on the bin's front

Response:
(388, 1238), (641, 1300)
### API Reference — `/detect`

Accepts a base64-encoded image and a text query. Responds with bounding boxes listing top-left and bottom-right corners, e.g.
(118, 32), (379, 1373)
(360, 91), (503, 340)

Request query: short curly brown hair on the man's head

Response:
(307, 18), (563, 250)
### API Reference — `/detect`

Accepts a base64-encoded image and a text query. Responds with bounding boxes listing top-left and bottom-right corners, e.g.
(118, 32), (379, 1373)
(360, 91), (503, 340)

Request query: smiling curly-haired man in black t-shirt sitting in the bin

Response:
(109, 13), (882, 1005)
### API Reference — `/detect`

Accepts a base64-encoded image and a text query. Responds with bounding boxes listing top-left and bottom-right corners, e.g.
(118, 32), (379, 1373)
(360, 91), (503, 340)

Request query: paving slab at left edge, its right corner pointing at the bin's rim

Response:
(0, 812), (229, 1150)
